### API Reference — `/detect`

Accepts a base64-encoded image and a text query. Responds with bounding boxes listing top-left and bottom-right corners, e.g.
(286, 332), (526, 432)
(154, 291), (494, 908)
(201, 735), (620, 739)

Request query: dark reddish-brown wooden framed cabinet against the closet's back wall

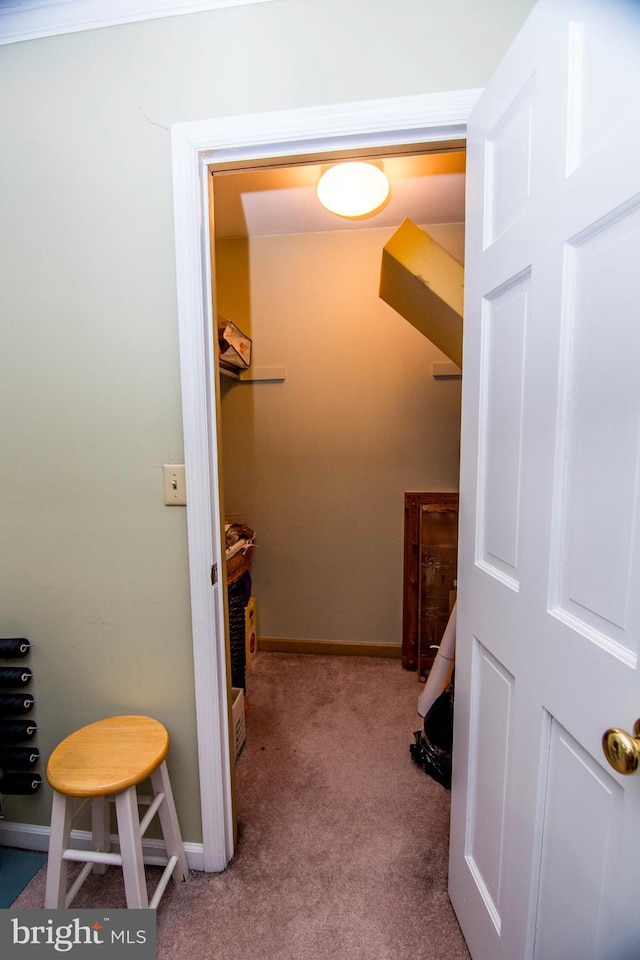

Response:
(402, 493), (458, 680)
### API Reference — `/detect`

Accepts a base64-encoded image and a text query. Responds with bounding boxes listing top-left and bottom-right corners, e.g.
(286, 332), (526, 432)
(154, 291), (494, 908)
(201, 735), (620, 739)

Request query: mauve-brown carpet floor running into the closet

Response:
(14, 653), (469, 960)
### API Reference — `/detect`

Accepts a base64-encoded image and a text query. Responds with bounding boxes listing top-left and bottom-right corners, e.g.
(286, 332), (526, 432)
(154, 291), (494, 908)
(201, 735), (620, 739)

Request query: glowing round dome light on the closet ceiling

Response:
(318, 160), (389, 217)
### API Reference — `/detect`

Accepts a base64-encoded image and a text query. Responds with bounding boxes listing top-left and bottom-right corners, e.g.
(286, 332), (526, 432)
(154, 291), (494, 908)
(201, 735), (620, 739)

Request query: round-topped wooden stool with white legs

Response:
(44, 717), (189, 909)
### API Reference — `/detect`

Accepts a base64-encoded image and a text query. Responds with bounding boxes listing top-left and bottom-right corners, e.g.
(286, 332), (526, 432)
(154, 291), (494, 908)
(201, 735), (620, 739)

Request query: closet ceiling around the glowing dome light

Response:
(214, 150), (465, 239)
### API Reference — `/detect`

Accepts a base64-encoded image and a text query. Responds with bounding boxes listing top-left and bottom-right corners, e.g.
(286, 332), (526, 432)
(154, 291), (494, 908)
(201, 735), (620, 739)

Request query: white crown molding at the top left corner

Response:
(0, 0), (274, 44)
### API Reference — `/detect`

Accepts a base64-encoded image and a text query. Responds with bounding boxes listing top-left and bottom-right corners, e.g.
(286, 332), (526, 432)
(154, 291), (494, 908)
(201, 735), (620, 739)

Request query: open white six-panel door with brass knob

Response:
(450, 0), (640, 960)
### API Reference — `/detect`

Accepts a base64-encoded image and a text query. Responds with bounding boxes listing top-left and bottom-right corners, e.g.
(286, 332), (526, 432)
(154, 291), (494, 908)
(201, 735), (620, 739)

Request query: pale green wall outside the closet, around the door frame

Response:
(0, 0), (532, 841)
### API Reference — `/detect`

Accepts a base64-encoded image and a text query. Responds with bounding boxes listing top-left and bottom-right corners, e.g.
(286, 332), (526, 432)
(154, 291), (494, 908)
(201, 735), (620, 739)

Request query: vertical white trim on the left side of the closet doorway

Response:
(171, 129), (233, 872)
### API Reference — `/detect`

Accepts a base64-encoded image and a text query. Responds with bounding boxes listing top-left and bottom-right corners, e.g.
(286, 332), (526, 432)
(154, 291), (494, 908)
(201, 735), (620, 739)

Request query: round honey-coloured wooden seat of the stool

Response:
(47, 716), (169, 797)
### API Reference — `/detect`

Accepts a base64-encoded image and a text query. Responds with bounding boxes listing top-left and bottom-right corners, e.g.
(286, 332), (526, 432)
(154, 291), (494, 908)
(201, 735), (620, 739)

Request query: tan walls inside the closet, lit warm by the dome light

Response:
(218, 224), (464, 644)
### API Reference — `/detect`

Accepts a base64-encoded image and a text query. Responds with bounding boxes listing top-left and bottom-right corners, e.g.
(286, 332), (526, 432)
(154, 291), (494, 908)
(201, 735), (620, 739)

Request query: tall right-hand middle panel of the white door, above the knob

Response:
(553, 207), (640, 652)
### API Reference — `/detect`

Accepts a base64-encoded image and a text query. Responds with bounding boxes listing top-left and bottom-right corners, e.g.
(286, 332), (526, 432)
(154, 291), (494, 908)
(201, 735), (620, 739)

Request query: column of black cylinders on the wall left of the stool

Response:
(0, 637), (42, 795)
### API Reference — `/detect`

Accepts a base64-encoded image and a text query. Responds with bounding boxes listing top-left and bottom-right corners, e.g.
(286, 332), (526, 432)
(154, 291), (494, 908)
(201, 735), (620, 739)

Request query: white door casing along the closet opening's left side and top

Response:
(171, 90), (481, 872)
